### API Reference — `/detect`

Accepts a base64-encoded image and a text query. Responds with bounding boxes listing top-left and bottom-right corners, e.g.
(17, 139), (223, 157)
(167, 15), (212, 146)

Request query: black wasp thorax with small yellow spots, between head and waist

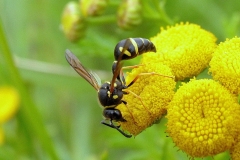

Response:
(98, 81), (124, 108)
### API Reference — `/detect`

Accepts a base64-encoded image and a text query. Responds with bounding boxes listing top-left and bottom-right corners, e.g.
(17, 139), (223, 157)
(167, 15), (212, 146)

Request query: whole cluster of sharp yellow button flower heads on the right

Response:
(117, 23), (240, 159)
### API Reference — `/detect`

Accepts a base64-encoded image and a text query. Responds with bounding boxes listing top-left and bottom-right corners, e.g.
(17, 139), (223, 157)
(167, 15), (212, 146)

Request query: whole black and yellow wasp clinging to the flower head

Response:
(65, 38), (156, 138)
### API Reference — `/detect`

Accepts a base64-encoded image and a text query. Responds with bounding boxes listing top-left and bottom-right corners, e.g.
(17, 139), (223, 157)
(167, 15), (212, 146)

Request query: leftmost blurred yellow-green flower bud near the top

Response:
(61, 1), (85, 42)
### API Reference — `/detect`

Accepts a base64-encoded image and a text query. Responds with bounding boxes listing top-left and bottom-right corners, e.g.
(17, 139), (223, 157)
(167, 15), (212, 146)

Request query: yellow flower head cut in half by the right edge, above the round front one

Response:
(209, 37), (240, 94)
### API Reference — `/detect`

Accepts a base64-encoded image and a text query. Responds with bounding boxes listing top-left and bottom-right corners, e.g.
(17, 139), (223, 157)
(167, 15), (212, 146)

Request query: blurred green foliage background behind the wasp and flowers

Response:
(0, 0), (240, 160)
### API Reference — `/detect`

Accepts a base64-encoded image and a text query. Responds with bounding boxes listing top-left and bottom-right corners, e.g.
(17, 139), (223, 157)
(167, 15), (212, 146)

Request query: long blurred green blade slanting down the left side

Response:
(0, 20), (59, 160)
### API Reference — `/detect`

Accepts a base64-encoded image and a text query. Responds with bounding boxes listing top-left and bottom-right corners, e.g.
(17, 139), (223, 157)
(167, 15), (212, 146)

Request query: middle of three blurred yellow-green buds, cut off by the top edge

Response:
(79, 0), (108, 16)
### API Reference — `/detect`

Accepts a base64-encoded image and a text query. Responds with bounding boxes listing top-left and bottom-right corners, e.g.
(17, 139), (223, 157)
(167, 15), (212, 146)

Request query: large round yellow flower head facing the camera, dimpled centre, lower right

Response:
(166, 79), (240, 157)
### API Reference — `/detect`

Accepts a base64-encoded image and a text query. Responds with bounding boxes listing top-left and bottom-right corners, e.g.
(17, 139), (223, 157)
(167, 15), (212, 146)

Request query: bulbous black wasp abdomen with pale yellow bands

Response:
(114, 38), (156, 60)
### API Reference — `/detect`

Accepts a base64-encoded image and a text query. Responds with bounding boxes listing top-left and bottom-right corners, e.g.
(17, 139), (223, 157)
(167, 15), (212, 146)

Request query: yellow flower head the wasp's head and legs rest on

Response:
(117, 63), (176, 136)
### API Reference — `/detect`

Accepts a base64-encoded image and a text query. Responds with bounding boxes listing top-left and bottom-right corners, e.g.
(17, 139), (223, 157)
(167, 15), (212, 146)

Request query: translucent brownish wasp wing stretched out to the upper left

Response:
(65, 49), (101, 91)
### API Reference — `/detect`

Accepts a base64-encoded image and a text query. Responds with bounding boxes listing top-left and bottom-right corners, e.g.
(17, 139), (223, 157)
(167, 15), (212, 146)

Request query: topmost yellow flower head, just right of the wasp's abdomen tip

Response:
(142, 23), (217, 80)
